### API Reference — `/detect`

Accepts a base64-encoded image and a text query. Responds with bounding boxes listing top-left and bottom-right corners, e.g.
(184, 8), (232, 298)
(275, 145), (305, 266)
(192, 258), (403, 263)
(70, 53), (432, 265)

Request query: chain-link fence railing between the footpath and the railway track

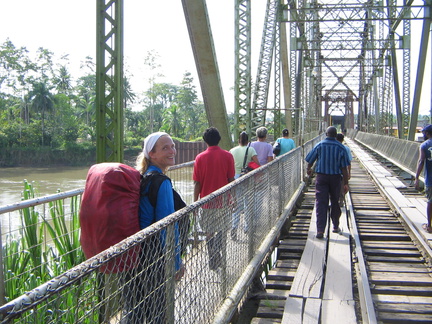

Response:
(0, 140), (322, 323)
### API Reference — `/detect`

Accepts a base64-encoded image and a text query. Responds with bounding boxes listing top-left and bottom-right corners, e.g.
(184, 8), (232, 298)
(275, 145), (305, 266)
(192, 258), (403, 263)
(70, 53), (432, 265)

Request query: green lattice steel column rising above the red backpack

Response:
(96, 0), (123, 163)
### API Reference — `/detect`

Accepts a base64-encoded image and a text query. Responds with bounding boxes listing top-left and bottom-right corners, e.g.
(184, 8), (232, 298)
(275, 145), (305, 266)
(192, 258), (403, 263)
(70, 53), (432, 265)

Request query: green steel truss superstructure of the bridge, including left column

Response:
(96, 0), (432, 162)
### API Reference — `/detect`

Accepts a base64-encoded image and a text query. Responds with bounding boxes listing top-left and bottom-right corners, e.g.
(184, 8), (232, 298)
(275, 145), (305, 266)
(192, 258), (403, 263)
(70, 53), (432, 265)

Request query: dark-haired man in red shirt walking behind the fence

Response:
(193, 127), (235, 270)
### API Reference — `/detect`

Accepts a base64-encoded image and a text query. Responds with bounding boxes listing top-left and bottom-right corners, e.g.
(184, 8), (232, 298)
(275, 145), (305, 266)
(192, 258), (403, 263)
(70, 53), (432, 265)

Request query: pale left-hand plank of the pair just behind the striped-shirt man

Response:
(290, 209), (326, 298)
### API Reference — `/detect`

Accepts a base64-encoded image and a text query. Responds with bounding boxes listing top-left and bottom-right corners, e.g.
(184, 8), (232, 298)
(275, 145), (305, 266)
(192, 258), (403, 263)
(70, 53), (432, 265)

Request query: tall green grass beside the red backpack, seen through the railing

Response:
(2, 180), (96, 323)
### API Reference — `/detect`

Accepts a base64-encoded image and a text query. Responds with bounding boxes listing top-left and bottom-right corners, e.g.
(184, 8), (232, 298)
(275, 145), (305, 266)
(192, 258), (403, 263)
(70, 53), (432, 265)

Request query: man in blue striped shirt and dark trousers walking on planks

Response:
(305, 126), (350, 238)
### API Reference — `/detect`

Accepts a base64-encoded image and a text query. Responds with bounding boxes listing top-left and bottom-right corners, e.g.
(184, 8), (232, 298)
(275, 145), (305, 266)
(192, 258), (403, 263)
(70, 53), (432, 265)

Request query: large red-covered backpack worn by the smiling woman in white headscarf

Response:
(79, 163), (141, 273)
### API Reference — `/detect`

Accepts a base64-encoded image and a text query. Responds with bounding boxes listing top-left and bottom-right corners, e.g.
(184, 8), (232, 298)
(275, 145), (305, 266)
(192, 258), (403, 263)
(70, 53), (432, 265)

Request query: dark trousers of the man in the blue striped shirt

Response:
(315, 173), (342, 233)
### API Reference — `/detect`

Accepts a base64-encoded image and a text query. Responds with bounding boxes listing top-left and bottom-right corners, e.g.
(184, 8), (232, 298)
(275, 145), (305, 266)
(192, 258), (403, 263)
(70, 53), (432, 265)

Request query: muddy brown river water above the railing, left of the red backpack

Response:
(0, 167), (89, 206)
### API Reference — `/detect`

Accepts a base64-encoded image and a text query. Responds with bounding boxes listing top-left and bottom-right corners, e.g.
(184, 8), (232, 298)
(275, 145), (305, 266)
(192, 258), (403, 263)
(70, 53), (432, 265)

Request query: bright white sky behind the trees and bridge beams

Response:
(0, 0), (431, 114)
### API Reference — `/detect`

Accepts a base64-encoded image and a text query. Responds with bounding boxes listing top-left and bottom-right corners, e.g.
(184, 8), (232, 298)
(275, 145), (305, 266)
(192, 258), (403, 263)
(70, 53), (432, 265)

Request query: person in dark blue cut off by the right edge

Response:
(414, 125), (432, 233)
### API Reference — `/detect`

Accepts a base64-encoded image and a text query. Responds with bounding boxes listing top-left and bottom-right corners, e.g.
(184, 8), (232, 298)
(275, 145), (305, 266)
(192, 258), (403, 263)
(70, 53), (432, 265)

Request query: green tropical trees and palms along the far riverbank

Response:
(0, 40), (207, 166)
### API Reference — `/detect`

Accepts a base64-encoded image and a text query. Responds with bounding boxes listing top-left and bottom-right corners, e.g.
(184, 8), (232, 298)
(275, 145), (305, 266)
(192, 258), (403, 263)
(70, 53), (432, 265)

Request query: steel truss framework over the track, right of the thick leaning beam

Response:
(236, 0), (430, 139)
